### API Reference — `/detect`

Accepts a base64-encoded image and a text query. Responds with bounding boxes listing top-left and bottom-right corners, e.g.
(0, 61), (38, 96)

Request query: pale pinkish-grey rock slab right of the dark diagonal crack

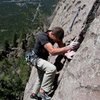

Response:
(52, 12), (100, 100)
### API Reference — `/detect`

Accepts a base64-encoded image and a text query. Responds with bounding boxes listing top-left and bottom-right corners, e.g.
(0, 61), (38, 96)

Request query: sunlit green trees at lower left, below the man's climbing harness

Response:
(0, 57), (30, 100)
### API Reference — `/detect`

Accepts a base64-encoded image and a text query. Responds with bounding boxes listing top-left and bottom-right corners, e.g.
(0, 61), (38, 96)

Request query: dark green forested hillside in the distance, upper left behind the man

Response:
(0, 0), (57, 49)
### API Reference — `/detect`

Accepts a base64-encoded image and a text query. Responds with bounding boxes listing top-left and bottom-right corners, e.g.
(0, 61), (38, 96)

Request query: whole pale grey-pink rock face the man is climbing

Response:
(24, 0), (100, 100)
